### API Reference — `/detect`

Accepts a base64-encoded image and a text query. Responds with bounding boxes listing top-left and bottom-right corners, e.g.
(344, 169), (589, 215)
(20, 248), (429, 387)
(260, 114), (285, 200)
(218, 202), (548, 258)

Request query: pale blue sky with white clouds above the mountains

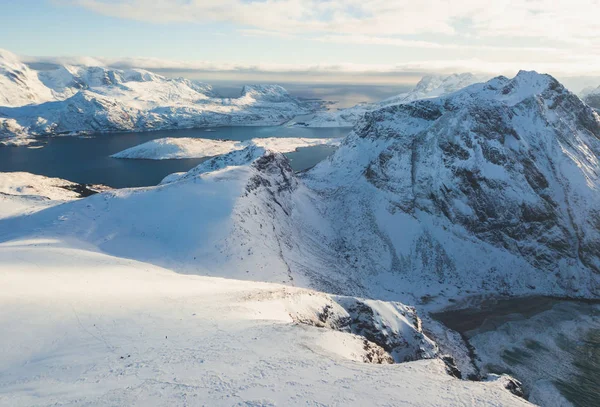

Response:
(0, 0), (600, 88)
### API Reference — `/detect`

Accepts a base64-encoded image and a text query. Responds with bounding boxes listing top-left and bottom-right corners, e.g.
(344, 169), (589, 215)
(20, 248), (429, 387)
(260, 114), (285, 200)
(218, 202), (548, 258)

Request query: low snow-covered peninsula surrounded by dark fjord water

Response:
(112, 137), (341, 160)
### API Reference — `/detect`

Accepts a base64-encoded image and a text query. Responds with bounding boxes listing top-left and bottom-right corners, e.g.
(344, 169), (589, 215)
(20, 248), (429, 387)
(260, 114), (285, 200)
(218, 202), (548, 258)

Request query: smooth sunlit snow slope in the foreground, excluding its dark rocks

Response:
(0, 240), (529, 407)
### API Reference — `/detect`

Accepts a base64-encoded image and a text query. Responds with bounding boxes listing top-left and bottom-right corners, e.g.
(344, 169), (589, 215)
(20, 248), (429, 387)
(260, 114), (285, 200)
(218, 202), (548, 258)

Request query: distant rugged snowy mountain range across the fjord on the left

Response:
(0, 51), (315, 143)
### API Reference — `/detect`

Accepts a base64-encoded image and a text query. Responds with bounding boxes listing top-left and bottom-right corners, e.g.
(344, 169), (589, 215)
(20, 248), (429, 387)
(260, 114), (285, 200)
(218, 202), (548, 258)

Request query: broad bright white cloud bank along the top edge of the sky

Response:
(71, 0), (600, 46)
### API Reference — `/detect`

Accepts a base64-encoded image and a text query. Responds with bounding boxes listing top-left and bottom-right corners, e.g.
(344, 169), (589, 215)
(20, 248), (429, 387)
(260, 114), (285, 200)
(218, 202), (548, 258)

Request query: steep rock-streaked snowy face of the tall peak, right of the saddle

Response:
(307, 72), (600, 295)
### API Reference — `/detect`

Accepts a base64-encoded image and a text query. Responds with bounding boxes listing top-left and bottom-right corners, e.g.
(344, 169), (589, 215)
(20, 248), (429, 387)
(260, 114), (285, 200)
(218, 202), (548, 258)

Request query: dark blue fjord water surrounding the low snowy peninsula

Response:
(0, 126), (349, 188)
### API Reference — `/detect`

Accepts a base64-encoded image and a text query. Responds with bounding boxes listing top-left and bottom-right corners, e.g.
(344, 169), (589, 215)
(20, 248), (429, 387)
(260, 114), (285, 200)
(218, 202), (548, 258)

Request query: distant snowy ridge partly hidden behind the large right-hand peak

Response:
(298, 73), (482, 127)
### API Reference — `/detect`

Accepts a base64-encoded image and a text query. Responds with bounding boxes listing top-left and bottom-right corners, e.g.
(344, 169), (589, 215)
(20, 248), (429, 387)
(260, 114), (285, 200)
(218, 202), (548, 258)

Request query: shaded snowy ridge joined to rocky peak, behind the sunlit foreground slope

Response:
(3, 72), (600, 302)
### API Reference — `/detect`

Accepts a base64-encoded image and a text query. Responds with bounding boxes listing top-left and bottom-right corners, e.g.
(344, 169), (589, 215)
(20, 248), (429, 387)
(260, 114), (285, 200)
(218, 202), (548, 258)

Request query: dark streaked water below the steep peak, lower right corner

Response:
(435, 297), (600, 407)
